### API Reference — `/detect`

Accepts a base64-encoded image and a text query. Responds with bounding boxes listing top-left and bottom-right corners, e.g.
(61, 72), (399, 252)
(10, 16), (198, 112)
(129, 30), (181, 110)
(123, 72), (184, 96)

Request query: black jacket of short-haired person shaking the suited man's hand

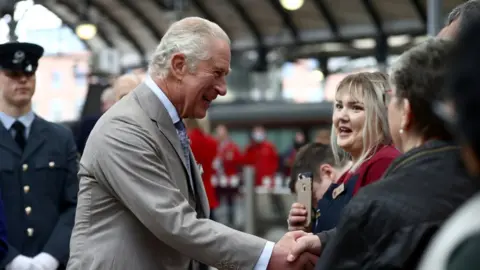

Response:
(316, 141), (479, 270)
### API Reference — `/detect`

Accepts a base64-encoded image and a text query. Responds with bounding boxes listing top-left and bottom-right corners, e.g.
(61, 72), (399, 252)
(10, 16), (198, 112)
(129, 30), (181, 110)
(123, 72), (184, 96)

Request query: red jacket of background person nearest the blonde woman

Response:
(244, 140), (279, 187)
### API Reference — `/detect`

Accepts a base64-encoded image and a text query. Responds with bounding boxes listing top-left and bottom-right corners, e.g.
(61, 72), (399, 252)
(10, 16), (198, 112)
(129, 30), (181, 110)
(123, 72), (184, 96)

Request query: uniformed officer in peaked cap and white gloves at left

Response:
(0, 42), (78, 270)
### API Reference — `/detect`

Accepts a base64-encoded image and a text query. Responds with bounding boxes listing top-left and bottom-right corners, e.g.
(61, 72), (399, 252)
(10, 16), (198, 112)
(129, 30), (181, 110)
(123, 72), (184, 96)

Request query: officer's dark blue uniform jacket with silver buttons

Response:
(0, 116), (78, 267)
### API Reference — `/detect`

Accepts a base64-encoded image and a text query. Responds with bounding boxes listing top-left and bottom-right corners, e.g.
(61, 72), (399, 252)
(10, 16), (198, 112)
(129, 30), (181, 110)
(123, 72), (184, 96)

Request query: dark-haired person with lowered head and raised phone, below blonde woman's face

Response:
(288, 143), (352, 233)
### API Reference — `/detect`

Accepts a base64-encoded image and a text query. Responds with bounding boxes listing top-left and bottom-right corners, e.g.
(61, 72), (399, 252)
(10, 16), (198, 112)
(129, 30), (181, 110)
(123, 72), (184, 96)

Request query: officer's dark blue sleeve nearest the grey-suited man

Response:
(43, 131), (78, 264)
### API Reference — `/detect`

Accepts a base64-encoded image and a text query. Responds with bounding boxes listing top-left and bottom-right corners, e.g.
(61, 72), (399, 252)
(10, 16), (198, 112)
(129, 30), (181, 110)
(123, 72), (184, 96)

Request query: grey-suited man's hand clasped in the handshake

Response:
(267, 231), (318, 270)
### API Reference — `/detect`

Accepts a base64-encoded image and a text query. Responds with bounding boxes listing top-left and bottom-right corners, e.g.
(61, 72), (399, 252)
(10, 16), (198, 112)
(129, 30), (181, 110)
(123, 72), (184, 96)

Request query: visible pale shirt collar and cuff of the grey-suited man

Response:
(145, 75), (275, 270)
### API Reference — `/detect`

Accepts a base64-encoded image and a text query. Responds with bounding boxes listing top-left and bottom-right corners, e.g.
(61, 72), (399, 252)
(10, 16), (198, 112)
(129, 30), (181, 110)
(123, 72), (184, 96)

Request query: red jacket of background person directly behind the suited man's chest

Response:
(188, 128), (219, 209)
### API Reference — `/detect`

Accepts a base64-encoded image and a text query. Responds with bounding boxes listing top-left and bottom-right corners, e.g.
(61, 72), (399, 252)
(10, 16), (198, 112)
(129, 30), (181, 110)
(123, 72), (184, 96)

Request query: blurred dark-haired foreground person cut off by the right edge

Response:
(419, 17), (480, 270)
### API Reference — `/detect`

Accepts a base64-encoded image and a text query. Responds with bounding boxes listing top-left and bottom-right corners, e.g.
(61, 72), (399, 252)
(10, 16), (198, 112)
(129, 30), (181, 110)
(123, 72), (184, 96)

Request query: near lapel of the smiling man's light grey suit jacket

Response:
(134, 83), (193, 187)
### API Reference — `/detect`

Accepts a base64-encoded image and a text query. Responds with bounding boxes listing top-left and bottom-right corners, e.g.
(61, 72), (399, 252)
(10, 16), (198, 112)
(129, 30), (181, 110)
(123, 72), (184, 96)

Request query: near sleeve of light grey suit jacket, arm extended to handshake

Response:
(94, 119), (266, 269)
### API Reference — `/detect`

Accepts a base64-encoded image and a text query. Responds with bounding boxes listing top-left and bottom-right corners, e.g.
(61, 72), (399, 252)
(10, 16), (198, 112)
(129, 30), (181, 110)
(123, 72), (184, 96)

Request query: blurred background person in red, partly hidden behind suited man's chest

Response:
(184, 117), (218, 220)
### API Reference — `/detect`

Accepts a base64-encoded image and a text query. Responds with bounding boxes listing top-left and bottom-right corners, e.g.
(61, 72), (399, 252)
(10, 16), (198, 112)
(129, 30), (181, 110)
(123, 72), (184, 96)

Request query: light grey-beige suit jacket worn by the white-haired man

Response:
(68, 84), (266, 270)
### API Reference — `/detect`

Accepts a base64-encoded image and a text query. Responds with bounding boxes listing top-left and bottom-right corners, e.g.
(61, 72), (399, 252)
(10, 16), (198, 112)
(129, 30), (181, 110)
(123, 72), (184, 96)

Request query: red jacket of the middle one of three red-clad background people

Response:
(217, 140), (243, 178)
